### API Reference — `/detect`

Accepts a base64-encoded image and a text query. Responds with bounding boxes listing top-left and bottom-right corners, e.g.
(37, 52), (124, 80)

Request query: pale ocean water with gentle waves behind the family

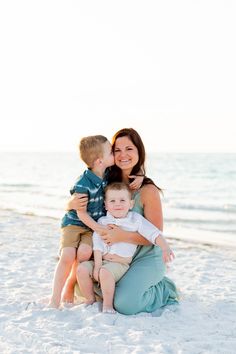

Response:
(0, 152), (236, 246)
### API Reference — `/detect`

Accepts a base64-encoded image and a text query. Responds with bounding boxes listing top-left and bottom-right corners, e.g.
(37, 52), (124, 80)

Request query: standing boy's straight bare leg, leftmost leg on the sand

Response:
(48, 247), (76, 308)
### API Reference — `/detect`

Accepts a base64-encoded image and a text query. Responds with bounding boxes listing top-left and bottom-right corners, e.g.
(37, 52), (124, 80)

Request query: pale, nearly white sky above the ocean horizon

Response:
(0, 0), (236, 152)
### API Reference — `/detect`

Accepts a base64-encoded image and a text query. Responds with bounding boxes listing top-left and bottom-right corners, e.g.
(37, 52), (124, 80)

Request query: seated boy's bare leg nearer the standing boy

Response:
(77, 264), (96, 305)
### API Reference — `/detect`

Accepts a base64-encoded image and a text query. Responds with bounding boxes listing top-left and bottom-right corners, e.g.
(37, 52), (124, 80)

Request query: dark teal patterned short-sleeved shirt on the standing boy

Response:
(61, 169), (107, 227)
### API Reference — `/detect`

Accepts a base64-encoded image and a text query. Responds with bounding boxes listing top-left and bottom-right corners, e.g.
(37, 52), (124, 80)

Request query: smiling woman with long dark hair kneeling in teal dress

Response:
(70, 128), (178, 315)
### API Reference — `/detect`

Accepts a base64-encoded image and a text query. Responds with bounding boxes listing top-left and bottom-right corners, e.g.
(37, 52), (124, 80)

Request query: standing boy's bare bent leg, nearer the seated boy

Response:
(62, 243), (92, 303)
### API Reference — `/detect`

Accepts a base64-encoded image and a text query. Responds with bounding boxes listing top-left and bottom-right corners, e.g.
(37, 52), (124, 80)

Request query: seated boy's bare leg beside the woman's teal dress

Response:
(99, 268), (116, 313)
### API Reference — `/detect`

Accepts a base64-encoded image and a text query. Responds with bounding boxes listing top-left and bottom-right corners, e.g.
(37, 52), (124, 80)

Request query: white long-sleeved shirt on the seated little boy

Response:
(93, 211), (161, 257)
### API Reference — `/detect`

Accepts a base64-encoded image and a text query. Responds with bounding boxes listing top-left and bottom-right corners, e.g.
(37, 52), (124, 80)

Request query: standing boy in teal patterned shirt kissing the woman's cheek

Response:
(49, 135), (114, 308)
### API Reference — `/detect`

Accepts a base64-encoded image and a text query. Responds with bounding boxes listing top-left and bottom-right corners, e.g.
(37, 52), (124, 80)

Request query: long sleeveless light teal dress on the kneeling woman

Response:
(114, 193), (178, 315)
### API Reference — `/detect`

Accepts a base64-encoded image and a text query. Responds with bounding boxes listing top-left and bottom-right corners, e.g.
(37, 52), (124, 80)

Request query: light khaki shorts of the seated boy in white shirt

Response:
(81, 260), (129, 282)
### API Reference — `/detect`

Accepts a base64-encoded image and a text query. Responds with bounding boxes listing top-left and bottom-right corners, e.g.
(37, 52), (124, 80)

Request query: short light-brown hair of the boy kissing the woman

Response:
(79, 135), (107, 168)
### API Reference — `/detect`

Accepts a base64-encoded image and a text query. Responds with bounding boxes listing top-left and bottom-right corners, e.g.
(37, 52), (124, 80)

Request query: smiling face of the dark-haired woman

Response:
(114, 136), (139, 171)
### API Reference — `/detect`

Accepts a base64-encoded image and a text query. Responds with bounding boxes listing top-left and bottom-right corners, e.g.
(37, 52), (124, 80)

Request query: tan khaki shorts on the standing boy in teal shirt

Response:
(60, 225), (93, 250)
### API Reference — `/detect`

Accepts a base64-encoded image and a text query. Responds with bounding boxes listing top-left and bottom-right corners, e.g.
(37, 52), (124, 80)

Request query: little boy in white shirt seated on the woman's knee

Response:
(78, 182), (174, 313)
